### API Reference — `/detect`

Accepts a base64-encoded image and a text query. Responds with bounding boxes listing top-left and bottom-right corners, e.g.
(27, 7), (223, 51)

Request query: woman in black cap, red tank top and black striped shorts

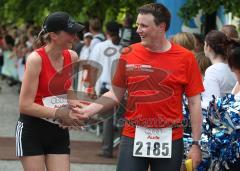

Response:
(16, 12), (83, 171)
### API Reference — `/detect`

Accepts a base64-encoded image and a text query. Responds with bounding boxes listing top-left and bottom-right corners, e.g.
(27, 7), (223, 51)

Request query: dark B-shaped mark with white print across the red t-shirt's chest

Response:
(126, 64), (174, 111)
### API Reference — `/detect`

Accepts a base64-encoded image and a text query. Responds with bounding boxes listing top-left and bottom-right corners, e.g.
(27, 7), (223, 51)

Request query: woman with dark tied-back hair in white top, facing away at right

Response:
(202, 30), (236, 108)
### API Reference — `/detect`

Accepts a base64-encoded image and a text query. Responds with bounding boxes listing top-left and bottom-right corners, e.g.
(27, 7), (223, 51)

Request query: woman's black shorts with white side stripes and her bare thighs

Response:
(16, 115), (70, 171)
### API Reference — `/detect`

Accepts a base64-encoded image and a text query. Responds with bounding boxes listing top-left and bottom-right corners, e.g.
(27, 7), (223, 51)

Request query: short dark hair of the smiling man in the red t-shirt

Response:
(137, 3), (171, 31)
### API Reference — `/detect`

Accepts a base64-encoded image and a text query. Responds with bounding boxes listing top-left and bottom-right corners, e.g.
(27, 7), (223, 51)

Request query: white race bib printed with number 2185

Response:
(133, 126), (172, 158)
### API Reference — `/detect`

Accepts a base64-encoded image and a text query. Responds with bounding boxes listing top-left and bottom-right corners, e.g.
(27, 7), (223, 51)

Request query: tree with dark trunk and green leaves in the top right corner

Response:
(179, 0), (240, 34)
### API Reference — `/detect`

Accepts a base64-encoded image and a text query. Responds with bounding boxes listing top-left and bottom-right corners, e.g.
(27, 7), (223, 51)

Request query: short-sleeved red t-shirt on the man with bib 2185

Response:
(112, 43), (204, 140)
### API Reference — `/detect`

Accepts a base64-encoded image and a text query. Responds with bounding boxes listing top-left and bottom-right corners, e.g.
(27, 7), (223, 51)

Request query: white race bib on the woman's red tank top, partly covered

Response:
(42, 94), (68, 108)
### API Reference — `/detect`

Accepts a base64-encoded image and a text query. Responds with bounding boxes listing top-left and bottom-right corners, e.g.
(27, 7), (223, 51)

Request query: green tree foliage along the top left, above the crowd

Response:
(0, 0), (153, 25)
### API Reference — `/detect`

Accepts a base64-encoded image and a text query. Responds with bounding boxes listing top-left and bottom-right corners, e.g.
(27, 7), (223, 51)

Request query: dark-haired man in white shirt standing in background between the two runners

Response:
(90, 21), (122, 158)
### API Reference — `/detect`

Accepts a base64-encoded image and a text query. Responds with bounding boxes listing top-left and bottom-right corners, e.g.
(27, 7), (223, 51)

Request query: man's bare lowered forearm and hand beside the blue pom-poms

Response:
(188, 94), (202, 169)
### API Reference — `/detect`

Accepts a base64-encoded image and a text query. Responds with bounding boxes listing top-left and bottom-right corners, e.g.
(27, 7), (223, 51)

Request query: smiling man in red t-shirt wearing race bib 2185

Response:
(72, 3), (204, 171)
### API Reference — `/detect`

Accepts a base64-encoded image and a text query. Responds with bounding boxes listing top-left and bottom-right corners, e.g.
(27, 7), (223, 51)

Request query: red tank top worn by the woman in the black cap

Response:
(34, 47), (72, 105)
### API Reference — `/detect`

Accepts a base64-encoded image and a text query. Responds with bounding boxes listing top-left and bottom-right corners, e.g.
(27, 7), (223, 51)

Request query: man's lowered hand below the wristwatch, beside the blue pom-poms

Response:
(188, 145), (202, 169)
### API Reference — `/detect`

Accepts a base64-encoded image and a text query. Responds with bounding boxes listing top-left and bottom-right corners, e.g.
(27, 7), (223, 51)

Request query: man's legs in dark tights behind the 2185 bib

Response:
(117, 136), (183, 171)
